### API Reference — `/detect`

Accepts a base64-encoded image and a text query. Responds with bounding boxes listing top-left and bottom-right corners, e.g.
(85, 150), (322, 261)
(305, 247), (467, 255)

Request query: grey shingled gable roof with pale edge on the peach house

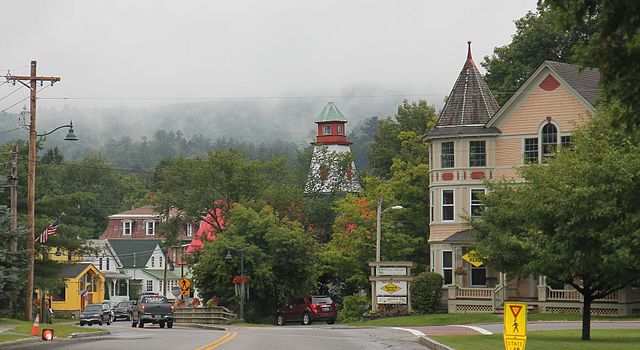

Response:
(486, 61), (600, 129)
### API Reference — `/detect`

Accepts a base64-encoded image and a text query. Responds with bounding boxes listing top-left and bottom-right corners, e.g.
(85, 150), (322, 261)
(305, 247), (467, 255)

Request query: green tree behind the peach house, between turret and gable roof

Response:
(481, 5), (592, 105)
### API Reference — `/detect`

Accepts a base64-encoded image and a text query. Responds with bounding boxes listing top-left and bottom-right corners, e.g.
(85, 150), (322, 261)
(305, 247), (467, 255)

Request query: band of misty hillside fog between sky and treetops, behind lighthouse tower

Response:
(0, 90), (441, 159)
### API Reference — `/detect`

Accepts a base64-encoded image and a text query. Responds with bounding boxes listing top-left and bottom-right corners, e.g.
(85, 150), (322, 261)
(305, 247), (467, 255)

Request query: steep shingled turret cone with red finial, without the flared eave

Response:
(436, 41), (498, 127)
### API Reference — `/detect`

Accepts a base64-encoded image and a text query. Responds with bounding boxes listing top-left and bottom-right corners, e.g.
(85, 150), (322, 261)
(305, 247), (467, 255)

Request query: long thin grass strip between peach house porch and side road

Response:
(350, 313), (640, 327)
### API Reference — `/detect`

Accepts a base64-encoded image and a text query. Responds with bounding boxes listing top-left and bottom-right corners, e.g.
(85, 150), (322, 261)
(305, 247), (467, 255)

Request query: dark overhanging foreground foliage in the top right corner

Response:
(544, 0), (640, 129)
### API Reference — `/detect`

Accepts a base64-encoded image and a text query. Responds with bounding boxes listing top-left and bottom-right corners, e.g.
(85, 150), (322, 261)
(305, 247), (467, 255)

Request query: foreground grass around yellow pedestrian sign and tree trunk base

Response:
(430, 329), (640, 350)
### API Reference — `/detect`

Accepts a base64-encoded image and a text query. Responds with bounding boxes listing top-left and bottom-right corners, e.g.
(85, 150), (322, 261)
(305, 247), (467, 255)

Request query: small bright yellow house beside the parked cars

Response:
(49, 263), (105, 311)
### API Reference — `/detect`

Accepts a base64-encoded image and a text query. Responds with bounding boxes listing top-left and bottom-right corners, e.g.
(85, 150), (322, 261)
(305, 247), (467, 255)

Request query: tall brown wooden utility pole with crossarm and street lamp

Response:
(5, 60), (60, 321)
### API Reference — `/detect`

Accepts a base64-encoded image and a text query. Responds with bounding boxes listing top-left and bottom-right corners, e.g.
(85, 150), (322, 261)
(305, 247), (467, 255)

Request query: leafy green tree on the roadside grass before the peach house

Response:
(472, 111), (640, 340)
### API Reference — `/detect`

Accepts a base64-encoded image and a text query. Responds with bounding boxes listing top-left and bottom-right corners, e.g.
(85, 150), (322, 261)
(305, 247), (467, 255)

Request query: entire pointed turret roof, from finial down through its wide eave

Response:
(425, 41), (500, 138)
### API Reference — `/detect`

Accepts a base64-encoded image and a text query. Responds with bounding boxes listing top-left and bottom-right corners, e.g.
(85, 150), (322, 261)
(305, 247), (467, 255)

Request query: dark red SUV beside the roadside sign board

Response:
(278, 295), (338, 326)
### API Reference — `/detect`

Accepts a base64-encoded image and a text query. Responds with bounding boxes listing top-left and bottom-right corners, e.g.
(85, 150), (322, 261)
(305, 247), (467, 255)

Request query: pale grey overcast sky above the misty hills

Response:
(0, 0), (536, 112)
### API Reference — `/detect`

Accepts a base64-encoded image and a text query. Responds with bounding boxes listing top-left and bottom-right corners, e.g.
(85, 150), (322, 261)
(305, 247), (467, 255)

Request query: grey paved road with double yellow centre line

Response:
(45, 321), (425, 350)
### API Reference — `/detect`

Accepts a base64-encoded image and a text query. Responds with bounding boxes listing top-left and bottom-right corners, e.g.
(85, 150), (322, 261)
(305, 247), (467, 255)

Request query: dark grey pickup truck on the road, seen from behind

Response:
(131, 295), (173, 328)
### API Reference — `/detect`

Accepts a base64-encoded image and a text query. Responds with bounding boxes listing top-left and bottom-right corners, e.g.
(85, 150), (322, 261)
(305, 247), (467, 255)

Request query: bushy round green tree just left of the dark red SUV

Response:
(193, 202), (317, 321)
